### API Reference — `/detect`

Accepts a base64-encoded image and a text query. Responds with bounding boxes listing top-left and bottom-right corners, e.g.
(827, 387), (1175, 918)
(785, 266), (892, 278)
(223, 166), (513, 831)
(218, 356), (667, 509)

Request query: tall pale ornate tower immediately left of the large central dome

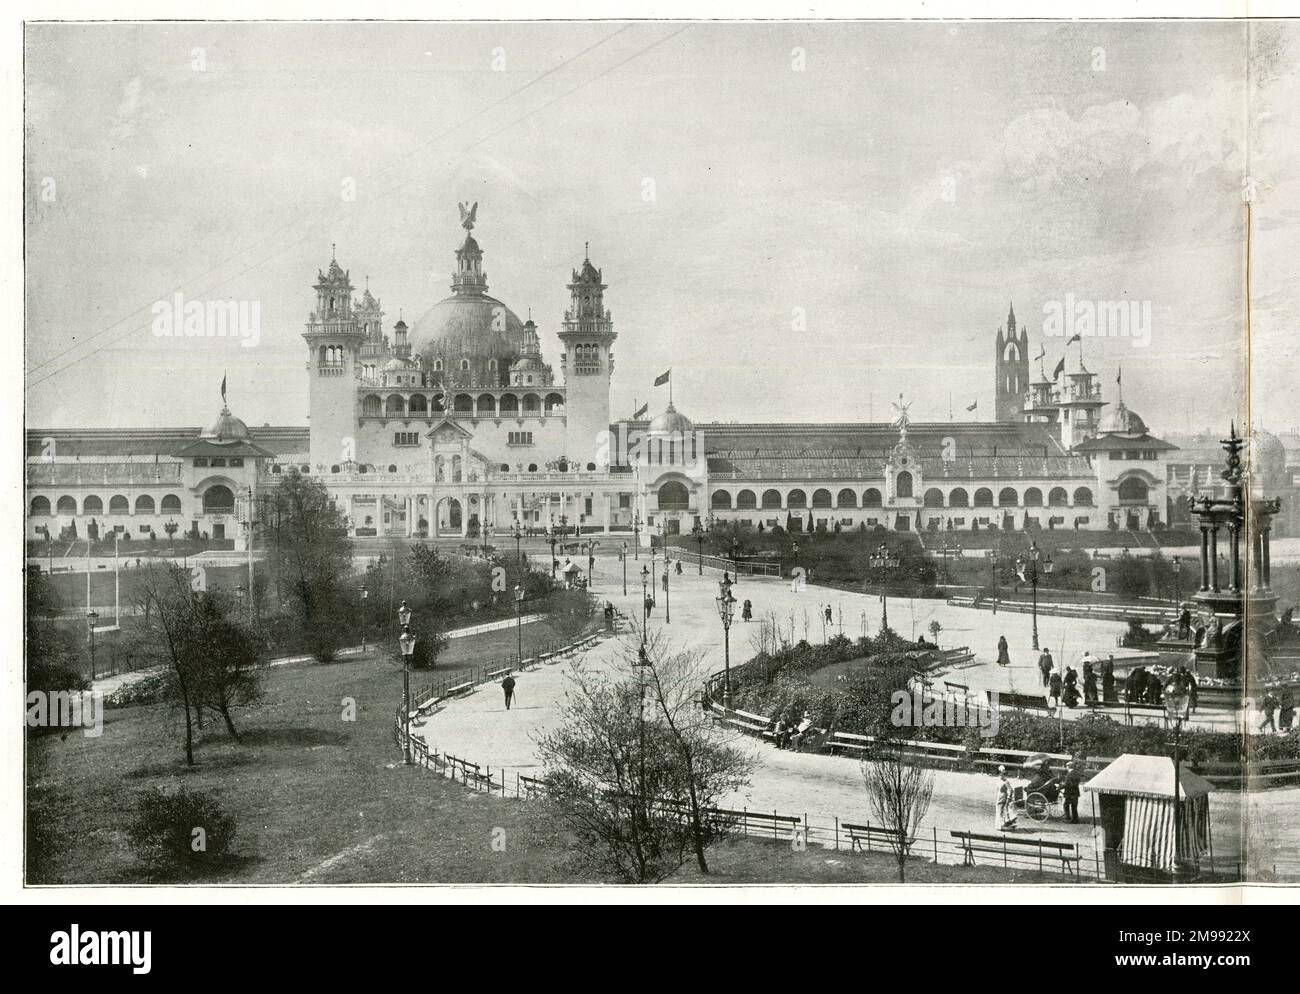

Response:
(303, 242), (364, 474)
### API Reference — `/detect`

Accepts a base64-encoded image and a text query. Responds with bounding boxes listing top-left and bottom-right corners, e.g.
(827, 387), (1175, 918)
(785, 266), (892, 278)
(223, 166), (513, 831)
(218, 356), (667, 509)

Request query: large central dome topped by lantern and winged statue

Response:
(411, 204), (525, 360)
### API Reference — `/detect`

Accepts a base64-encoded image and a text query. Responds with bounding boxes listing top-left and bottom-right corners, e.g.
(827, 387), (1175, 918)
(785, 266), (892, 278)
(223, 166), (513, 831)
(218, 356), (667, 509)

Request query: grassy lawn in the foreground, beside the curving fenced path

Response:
(27, 625), (1050, 885)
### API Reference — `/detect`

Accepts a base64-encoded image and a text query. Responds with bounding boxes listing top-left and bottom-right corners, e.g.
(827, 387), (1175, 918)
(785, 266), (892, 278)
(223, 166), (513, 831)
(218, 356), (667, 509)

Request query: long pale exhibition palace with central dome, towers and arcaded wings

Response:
(27, 205), (1300, 547)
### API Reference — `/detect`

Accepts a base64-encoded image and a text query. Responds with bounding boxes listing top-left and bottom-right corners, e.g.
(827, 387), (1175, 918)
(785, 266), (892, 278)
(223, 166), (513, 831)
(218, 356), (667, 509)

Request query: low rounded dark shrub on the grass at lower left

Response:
(127, 786), (235, 873)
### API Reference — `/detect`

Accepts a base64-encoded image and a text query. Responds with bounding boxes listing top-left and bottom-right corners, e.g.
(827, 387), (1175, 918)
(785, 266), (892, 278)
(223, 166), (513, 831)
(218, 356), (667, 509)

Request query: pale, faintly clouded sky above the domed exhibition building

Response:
(25, 22), (1300, 433)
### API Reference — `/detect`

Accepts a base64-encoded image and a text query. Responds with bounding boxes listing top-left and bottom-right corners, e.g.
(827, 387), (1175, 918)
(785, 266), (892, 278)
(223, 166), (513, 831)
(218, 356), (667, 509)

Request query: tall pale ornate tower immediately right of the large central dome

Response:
(559, 246), (618, 469)
